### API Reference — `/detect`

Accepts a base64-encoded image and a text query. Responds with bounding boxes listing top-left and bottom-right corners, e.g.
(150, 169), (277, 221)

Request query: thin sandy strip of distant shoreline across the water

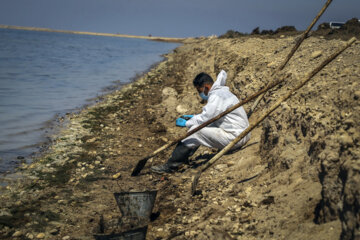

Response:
(0, 24), (186, 43)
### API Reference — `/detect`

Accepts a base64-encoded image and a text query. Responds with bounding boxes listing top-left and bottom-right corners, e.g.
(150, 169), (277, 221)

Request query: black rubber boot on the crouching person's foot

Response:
(151, 142), (198, 173)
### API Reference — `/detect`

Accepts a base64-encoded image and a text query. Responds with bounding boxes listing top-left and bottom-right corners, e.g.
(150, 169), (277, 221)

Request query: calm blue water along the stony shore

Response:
(0, 29), (177, 173)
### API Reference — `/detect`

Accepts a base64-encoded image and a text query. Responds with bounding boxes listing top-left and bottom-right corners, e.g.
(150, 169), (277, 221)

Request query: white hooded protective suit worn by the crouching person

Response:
(182, 70), (250, 149)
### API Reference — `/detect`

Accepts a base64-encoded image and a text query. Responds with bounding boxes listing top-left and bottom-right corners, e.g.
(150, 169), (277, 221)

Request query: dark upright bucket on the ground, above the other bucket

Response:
(114, 191), (157, 223)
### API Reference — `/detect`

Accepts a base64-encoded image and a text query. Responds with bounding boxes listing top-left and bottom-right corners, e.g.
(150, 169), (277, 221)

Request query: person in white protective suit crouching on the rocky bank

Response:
(151, 70), (250, 173)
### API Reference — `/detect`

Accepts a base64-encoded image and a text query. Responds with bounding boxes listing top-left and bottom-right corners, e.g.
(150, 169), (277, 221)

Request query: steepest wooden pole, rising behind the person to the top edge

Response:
(248, 0), (332, 118)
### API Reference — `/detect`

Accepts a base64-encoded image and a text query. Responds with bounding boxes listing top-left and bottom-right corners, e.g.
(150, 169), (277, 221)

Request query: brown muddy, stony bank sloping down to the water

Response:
(0, 29), (360, 240)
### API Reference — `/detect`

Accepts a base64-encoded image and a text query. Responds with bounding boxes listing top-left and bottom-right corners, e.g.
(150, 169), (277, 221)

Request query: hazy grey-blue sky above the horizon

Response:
(0, 0), (360, 37)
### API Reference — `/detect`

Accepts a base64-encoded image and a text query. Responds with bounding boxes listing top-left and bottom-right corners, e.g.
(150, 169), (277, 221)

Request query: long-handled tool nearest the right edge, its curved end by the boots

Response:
(191, 37), (356, 195)
